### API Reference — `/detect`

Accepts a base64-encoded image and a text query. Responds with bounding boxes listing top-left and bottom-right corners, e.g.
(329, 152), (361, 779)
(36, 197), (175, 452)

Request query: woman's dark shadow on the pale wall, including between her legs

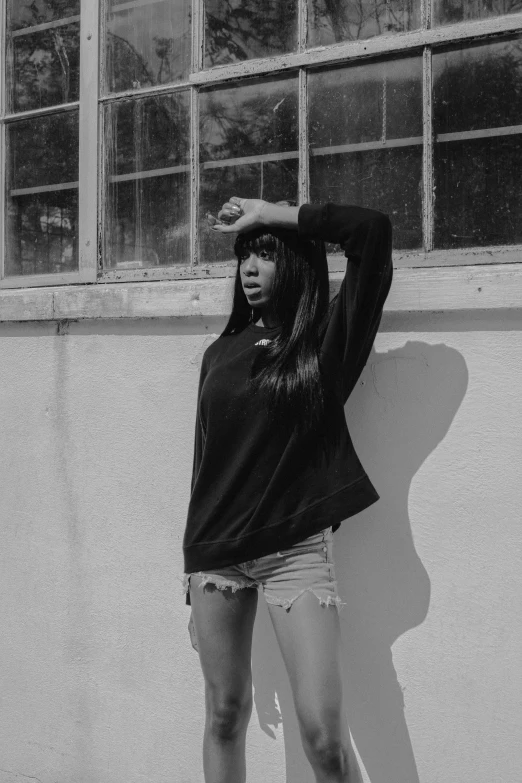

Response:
(248, 342), (468, 783)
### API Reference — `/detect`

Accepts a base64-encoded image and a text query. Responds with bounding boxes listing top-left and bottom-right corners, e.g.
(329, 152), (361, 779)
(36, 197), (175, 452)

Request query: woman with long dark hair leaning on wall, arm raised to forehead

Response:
(178, 197), (392, 783)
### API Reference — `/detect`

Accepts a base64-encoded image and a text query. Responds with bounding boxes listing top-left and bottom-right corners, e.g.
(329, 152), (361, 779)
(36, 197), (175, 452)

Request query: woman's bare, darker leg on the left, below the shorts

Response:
(190, 575), (258, 783)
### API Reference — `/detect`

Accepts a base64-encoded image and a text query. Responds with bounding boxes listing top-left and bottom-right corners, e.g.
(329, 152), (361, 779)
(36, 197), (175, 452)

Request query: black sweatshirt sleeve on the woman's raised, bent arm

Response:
(298, 203), (393, 402)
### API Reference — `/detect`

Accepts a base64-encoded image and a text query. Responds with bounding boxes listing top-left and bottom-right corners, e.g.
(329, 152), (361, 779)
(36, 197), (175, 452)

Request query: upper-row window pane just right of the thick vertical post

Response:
(105, 0), (190, 92)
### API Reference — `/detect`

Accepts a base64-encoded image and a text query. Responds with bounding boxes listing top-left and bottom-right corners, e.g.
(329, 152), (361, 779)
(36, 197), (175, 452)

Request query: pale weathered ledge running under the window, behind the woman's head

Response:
(0, 263), (522, 321)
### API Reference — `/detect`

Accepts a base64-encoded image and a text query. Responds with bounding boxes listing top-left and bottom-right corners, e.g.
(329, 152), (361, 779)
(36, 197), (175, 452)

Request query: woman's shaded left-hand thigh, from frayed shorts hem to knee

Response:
(190, 574), (258, 702)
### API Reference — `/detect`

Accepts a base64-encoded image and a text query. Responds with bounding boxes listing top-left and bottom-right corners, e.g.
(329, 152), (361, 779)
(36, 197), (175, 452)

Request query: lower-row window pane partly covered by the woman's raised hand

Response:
(200, 78), (298, 264)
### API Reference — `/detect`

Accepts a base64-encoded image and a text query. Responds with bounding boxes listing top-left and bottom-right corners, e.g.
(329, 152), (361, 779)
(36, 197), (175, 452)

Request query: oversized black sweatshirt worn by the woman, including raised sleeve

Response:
(183, 203), (393, 605)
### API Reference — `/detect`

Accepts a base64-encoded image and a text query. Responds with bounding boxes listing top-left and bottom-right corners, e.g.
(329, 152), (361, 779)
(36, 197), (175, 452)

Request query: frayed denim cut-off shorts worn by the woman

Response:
(180, 527), (345, 611)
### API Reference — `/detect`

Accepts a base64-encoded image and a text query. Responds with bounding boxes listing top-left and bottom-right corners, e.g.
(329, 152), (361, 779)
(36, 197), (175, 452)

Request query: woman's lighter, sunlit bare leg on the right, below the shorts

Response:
(268, 591), (363, 783)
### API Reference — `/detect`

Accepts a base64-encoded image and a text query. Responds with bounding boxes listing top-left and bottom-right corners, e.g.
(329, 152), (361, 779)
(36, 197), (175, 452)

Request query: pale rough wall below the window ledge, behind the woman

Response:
(0, 311), (522, 783)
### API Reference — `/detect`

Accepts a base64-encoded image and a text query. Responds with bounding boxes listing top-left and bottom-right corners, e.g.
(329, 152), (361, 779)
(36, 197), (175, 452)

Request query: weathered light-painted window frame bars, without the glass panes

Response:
(0, 0), (522, 289)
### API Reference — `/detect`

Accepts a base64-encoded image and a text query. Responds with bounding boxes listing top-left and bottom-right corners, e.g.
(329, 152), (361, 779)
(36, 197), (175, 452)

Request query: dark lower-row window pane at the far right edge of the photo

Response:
(433, 40), (522, 248)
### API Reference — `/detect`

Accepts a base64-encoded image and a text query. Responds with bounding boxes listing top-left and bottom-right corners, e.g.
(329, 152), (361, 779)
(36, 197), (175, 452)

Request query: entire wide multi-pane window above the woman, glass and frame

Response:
(0, 0), (522, 288)
